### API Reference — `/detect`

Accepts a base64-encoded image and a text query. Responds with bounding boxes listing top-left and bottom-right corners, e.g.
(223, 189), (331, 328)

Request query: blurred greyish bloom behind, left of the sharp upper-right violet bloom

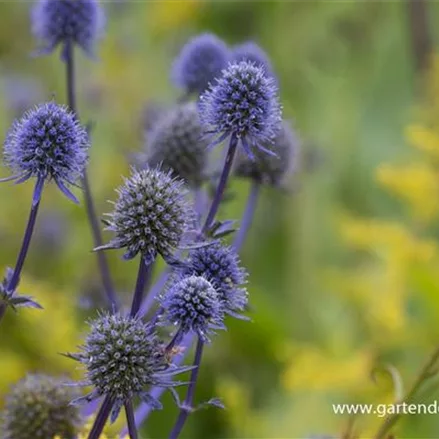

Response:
(147, 102), (207, 187)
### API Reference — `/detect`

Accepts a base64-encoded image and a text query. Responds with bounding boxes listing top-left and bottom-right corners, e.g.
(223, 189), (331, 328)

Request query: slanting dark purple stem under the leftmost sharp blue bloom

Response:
(0, 177), (44, 320)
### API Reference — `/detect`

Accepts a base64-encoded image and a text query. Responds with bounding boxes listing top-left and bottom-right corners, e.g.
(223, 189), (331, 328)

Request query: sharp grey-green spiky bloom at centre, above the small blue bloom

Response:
(97, 168), (195, 264)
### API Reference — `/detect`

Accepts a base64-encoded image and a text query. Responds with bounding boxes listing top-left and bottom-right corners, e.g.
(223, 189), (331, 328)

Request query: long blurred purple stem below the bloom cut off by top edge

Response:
(64, 40), (119, 311)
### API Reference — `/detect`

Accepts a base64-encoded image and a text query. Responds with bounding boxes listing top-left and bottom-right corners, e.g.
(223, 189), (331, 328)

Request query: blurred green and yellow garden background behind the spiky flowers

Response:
(0, 0), (439, 438)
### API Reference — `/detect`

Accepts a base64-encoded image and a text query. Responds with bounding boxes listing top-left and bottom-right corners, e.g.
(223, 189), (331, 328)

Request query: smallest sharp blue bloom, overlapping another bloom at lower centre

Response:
(159, 275), (224, 343)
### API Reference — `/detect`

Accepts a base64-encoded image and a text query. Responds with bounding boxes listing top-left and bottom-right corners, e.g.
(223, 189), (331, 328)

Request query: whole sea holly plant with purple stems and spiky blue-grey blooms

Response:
(0, 0), (295, 439)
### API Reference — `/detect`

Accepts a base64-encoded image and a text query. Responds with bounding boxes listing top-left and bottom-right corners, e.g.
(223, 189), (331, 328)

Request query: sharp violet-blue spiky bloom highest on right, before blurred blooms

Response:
(199, 61), (282, 157)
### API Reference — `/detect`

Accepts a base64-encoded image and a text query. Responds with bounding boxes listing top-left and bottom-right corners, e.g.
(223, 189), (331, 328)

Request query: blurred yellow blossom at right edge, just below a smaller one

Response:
(376, 162), (439, 223)
